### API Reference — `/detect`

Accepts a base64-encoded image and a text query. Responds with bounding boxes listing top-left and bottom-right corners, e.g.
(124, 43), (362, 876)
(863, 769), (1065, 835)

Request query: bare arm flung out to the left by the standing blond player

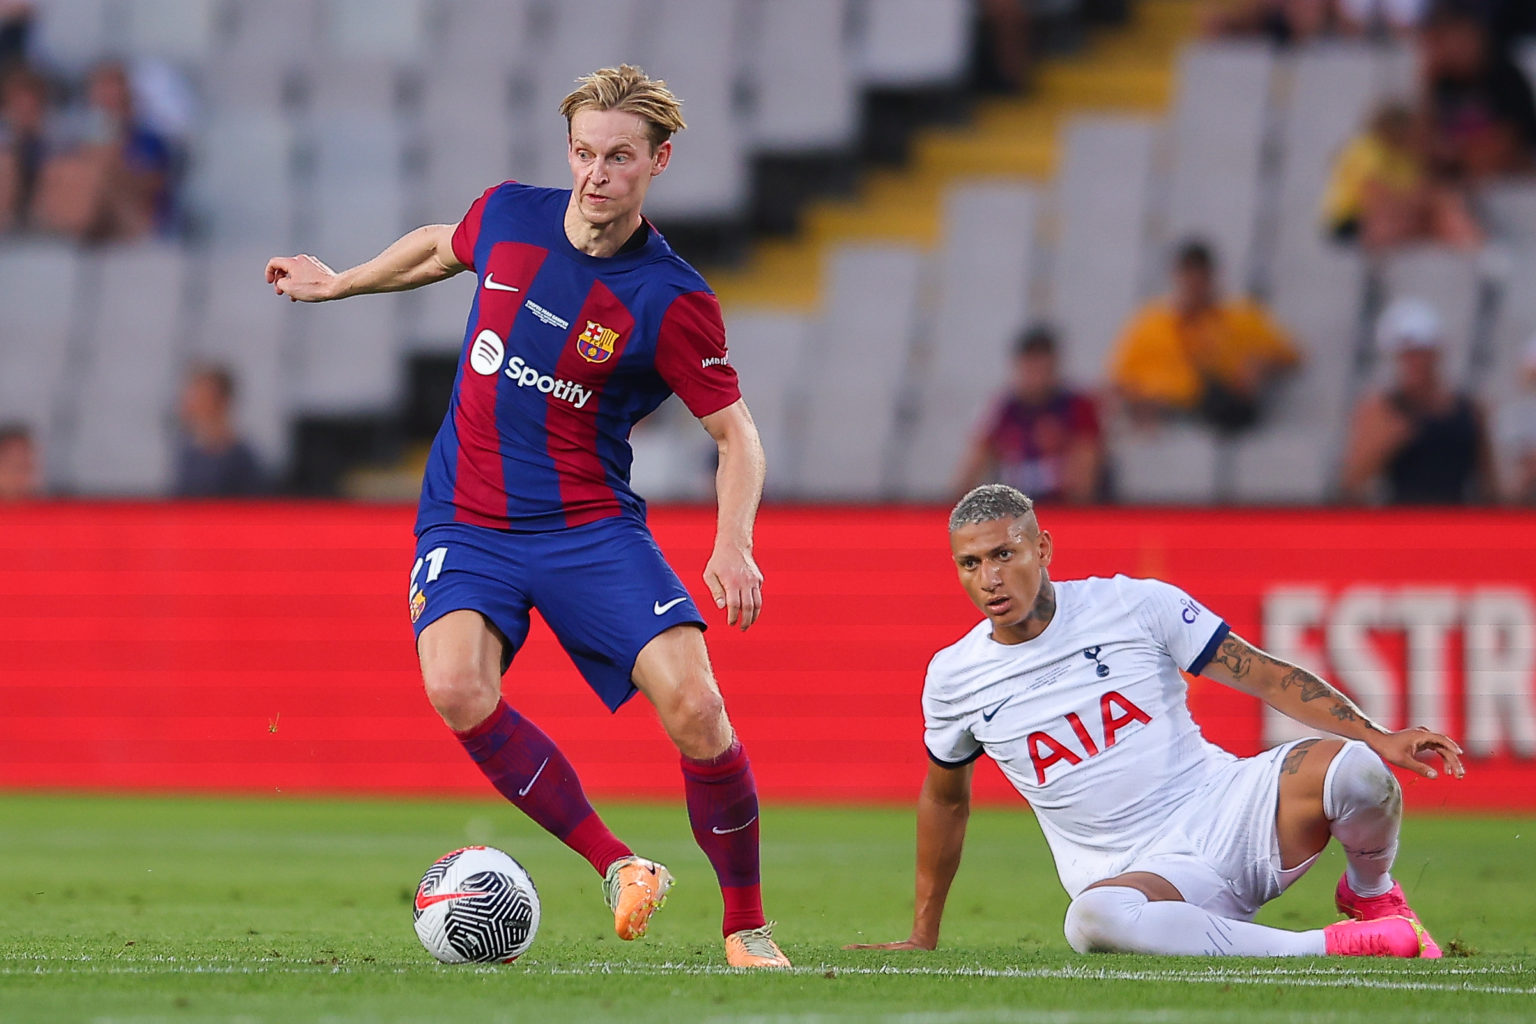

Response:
(267, 224), (464, 302)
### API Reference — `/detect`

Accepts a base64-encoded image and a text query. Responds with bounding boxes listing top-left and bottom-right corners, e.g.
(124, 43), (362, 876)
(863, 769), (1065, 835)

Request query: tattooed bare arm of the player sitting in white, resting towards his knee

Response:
(1203, 633), (1467, 778)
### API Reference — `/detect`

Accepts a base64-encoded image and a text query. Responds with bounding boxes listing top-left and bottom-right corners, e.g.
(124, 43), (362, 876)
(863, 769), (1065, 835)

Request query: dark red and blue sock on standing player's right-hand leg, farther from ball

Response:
(682, 740), (763, 935)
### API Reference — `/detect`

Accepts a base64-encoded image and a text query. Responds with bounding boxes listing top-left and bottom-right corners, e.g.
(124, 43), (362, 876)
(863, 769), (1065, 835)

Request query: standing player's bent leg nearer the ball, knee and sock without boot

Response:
(416, 609), (631, 875)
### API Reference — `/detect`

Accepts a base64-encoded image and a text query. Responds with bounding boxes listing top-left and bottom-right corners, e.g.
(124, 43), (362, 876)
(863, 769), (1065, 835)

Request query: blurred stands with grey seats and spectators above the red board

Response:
(0, 0), (1536, 505)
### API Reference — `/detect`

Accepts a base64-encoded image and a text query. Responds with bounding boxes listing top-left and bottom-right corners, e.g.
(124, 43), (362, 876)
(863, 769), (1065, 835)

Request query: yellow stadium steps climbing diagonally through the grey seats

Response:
(707, 0), (1200, 312)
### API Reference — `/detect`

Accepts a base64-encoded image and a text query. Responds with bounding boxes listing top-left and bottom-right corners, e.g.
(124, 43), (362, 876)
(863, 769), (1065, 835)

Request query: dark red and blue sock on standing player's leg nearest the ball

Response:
(453, 700), (632, 875)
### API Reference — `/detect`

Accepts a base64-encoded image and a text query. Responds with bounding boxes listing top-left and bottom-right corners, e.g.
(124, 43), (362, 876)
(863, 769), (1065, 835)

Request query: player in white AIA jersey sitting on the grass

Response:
(849, 484), (1464, 956)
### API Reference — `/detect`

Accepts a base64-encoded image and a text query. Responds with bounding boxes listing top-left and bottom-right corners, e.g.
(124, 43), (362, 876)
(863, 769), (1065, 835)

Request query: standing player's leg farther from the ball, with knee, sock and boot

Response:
(633, 626), (790, 967)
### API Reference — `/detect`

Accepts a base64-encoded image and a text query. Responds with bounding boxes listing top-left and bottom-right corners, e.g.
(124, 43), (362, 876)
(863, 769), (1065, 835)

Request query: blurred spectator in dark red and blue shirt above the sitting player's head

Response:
(955, 324), (1104, 504)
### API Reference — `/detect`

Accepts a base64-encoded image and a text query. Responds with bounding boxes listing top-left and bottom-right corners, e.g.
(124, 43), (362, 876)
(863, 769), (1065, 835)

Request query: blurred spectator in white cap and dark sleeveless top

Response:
(1341, 298), (1498, 505)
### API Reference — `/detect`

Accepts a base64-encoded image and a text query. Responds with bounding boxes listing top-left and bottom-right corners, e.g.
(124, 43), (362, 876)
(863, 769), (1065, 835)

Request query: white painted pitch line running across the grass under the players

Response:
(0, 955), (1536, 995)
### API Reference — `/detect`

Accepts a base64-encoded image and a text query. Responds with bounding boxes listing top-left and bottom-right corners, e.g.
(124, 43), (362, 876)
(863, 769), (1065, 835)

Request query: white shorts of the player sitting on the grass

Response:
(1124, 740), (1315, 921)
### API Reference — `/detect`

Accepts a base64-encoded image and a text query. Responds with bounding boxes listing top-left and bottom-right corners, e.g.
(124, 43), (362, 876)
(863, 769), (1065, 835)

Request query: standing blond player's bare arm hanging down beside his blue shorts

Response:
(699, 399), (766, 629)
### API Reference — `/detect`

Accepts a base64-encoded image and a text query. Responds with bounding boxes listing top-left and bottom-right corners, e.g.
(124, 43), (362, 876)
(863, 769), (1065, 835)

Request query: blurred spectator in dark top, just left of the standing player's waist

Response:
(175, 365), (267, 497)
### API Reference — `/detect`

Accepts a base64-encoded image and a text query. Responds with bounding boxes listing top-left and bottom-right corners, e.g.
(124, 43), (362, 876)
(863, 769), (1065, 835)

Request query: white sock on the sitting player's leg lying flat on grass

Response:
(1063, 886), (1327, 956)
